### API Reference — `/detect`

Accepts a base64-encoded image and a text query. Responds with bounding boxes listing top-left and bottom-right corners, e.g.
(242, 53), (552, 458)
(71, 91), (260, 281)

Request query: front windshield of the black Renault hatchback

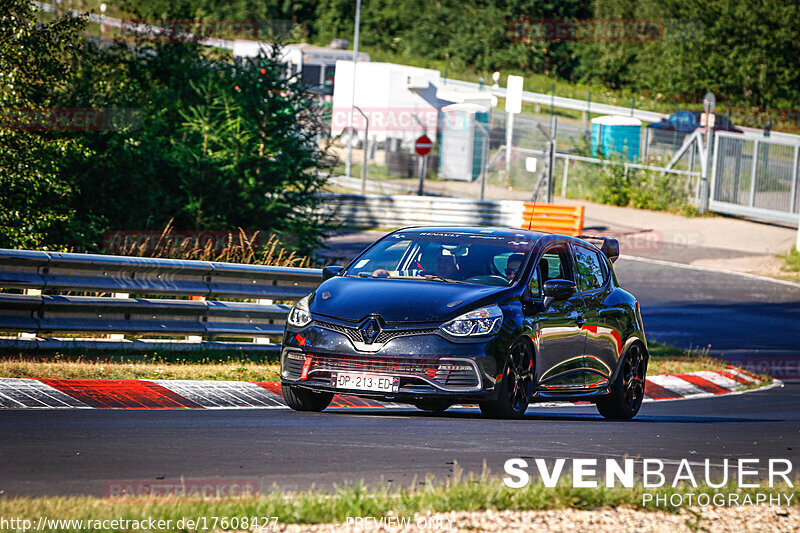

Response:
(344, 231), (533, 286)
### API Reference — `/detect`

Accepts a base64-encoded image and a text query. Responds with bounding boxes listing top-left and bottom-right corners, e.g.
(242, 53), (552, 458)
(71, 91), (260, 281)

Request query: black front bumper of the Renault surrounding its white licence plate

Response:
(281, 322), (501, 403)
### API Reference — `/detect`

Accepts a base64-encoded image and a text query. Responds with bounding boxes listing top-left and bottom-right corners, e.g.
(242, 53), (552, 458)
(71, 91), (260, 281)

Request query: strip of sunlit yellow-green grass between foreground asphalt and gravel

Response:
(0, 469), (800, 531)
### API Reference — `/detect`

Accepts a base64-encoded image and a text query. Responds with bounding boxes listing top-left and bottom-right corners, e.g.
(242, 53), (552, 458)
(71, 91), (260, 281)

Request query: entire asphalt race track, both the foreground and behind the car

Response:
(0, 259), (800, 496)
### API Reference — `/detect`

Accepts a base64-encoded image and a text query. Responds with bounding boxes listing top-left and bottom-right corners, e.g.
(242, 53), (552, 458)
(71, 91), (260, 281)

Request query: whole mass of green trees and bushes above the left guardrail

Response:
(0, 0), (330, 253)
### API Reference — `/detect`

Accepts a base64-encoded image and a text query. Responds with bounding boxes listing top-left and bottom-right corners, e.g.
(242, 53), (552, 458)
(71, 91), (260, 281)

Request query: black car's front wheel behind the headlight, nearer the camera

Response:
(479, 339), (534, 418)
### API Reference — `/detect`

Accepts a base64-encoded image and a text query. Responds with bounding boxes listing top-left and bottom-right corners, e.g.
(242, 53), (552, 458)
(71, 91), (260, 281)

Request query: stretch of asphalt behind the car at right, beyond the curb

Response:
(615, 258), (800, 372)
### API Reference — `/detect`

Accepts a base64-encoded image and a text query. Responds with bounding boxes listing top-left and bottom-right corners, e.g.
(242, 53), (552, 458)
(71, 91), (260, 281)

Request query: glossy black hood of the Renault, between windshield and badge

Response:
(310, 277), (509, 323)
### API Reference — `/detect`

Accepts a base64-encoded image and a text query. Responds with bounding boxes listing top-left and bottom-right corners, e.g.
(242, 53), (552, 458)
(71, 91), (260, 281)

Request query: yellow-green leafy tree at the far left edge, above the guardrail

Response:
(0, 0), (85, 248)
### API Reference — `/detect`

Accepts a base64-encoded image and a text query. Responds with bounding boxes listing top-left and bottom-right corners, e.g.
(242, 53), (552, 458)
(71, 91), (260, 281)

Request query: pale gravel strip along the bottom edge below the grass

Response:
(276, 506), (800, 533)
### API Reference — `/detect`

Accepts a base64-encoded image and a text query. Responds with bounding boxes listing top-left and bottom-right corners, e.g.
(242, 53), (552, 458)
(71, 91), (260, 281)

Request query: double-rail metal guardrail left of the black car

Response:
(0, 249), (321, 351)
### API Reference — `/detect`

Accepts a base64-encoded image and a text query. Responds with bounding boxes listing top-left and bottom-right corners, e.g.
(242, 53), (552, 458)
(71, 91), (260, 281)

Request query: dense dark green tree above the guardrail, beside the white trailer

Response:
(64, 37), (328, 252)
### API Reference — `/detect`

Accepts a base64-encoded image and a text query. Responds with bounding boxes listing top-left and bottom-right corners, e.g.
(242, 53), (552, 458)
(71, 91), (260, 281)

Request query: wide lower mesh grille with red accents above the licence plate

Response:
(309, 354), (480, 389)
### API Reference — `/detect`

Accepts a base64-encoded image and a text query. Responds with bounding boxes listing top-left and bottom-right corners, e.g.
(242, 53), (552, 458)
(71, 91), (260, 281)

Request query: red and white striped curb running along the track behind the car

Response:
(0, 366), (781, 409)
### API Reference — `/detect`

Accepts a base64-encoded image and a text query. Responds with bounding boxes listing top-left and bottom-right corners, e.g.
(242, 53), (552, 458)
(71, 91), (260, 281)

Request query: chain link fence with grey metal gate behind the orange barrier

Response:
(324, 110), (800, 224)
